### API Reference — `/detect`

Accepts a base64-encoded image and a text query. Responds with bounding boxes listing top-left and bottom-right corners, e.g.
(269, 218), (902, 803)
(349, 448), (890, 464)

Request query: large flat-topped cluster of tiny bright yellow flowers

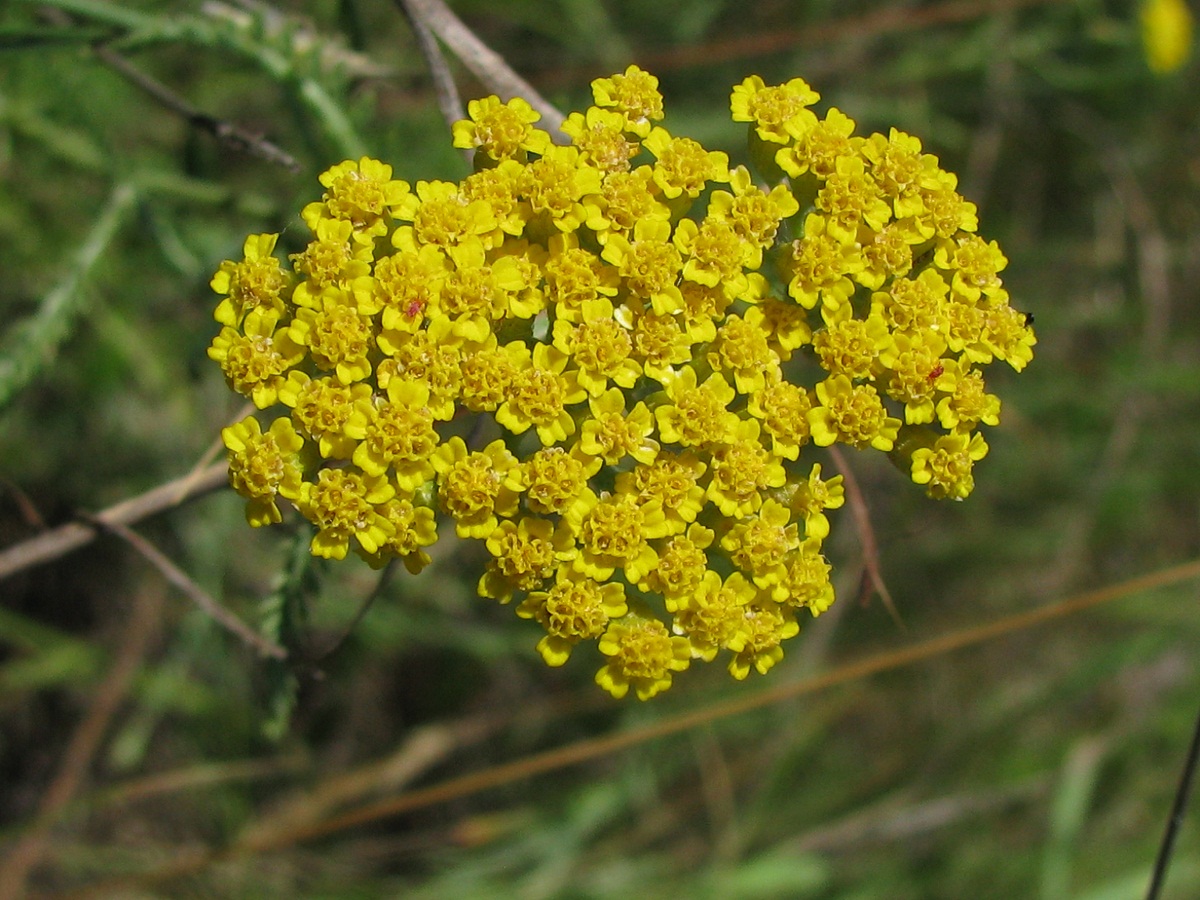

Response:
(209, 66), (1034, 700)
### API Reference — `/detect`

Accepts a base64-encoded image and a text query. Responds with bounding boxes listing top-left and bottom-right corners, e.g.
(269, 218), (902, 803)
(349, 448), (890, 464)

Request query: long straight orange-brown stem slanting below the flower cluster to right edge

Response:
(76, 559), (1200, 896)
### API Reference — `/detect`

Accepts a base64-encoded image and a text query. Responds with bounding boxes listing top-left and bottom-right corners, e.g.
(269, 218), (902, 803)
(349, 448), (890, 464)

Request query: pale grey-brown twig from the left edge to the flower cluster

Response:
(0, 462), (229, 581)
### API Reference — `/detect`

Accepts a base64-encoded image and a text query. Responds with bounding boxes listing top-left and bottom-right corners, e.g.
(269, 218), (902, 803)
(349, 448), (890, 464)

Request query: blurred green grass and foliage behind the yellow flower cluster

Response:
(0, 0), (1200, 900)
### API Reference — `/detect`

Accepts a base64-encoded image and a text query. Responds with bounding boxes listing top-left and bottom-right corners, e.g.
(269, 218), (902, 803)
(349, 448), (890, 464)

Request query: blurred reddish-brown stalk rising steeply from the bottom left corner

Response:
(0, 586), (163, 900)
